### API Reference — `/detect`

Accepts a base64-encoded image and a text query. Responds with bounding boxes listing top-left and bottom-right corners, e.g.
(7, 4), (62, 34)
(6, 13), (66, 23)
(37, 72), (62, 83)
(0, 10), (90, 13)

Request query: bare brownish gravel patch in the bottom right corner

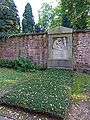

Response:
(67, 100), (90, 120)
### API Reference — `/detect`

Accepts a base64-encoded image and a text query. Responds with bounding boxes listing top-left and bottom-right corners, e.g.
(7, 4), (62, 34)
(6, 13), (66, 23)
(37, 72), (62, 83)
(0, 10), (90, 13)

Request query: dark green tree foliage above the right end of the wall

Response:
(59, 0), (89, 29)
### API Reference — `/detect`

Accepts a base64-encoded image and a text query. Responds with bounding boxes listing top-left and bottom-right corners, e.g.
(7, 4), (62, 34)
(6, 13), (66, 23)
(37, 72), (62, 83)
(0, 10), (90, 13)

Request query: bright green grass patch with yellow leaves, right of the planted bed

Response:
(72, 73), (90, 100)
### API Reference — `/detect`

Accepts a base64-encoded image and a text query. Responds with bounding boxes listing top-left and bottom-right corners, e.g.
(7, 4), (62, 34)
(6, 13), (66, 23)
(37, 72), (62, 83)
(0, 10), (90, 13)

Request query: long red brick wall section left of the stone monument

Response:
(0, 34), (48, 68)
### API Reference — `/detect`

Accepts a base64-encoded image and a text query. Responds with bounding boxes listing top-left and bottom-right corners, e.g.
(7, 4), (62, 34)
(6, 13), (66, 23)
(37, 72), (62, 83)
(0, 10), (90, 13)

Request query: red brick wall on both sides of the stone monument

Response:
(0, 31), (90, 69)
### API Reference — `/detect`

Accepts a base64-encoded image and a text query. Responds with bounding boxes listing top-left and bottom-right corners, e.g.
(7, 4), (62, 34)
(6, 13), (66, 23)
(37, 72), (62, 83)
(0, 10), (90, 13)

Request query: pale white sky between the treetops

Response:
(14, 0), (56, 23)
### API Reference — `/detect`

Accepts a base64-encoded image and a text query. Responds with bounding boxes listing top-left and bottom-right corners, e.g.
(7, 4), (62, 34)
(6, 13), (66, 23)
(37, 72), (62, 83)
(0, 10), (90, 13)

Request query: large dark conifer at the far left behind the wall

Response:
(0, 0), (20, 38)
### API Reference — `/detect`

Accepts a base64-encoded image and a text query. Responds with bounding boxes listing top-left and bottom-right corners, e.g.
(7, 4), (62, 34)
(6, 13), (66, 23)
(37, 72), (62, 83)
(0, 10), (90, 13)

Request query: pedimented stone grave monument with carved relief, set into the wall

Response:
(47, 26), (72, 69)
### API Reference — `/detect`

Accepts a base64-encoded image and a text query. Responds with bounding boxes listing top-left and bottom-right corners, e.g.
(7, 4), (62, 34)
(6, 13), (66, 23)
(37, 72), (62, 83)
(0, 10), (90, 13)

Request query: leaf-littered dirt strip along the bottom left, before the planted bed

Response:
(0, 106), (60, 120)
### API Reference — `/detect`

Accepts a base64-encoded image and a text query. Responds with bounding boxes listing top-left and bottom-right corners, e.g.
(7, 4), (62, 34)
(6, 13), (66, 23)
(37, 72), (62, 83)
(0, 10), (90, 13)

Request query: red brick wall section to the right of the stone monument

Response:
(73, 31), (90, 69)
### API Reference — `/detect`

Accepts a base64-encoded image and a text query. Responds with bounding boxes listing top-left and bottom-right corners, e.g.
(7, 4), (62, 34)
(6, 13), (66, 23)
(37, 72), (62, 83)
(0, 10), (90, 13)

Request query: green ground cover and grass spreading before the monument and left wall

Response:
(0, 68), (73, 117)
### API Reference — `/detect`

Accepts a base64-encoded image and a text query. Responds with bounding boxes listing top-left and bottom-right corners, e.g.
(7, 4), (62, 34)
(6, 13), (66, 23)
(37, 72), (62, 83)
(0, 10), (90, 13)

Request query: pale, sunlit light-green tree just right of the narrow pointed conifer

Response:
(38, 3), (61, 32)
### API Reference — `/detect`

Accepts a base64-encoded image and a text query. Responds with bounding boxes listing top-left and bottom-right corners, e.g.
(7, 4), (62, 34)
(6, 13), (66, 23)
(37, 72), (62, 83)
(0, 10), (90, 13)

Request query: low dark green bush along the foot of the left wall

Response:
(0, 57), (39, 71)
